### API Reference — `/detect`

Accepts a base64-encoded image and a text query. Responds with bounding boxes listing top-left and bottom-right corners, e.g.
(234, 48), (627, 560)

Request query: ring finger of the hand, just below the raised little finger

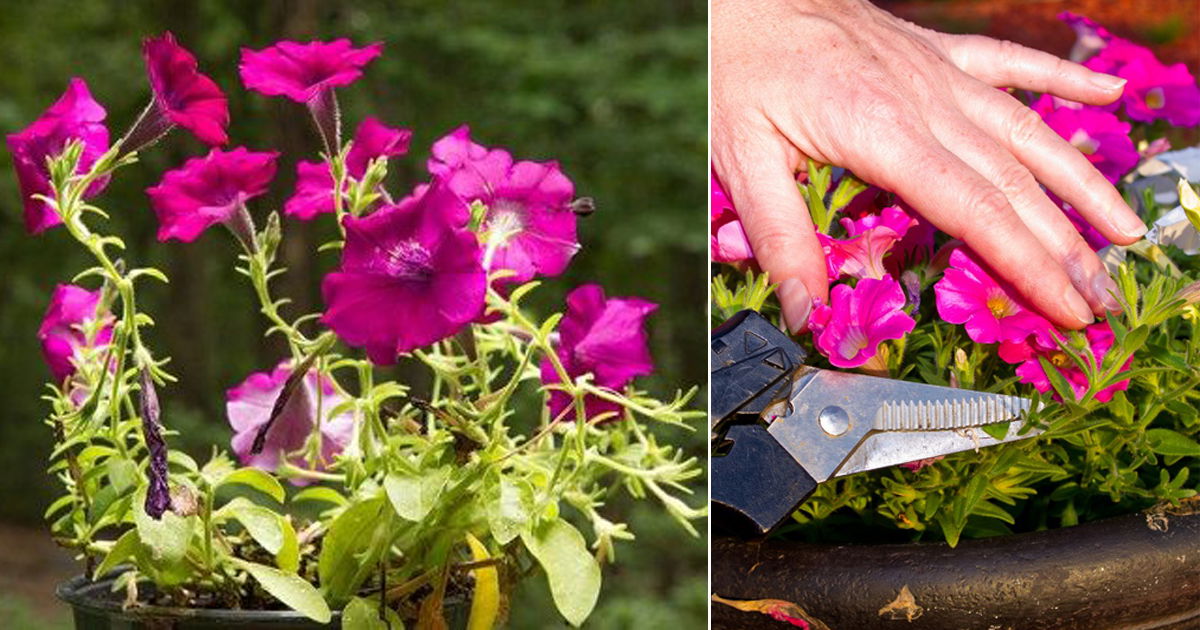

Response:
(958, 86), (1146, 245)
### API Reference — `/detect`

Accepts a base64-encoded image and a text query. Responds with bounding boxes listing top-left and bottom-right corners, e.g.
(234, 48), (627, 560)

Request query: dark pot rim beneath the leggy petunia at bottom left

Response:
(56, 575), (470, 630)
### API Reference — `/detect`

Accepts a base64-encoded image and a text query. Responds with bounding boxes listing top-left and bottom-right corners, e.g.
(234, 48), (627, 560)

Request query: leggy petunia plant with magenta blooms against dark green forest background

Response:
(8, 32), (704, 629)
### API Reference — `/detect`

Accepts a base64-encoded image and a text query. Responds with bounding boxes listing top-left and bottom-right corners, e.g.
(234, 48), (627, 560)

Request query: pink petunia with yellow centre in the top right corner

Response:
(1084, 37), (1200, 127)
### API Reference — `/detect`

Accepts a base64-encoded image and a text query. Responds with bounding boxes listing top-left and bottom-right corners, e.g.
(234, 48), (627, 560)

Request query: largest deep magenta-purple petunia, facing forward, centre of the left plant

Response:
(322, 181), (487, 365)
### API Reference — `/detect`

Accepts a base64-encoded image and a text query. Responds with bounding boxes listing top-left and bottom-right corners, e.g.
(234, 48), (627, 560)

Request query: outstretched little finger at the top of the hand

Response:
(942, 35), (1126, 106)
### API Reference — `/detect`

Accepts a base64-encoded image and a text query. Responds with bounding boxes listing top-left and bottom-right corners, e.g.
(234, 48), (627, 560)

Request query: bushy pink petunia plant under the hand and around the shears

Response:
(712, 13), (1200, 545)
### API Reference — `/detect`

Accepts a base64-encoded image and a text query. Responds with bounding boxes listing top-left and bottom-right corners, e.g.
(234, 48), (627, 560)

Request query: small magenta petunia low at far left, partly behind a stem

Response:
(37, 284), (113, 383)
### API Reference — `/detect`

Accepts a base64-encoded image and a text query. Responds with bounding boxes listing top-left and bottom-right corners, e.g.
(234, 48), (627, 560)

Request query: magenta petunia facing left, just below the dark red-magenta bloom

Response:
(146, 146), (280, 242)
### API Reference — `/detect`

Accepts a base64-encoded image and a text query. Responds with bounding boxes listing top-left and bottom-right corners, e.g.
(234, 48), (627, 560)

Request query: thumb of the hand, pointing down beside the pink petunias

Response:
(713, 139), (829, 332)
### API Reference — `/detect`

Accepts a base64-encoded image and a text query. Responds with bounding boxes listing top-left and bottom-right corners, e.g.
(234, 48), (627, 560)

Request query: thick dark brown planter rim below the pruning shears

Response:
(712, 514), (1200, 630)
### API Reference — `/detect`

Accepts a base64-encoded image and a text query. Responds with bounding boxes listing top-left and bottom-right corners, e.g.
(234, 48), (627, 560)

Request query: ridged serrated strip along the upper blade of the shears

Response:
(875, 390), (1030, 431)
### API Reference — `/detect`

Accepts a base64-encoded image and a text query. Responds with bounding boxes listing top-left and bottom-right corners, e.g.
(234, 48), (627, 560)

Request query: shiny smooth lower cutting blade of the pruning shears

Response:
(833, 420), (1042, 476)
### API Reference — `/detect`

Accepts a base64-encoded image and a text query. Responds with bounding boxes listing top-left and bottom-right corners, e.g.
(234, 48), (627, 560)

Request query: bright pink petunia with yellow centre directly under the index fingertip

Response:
(934, 247), (1050, 343)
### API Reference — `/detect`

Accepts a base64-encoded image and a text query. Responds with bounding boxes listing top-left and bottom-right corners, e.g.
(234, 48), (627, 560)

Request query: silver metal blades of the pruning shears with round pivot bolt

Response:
(764, 367), (1030, 482)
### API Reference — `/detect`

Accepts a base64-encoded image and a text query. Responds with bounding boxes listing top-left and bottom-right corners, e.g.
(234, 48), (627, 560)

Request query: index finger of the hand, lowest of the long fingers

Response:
(854, 127), (1093, 329)
